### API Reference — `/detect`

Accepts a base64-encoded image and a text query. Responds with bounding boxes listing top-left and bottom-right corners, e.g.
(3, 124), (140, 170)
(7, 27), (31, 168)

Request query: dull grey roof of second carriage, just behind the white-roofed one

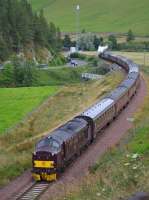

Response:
(107, 86), (127, 100)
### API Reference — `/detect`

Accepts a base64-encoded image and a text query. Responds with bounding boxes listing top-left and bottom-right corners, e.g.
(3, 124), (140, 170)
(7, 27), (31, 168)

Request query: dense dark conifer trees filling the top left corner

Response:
(0, 0), (61, 60)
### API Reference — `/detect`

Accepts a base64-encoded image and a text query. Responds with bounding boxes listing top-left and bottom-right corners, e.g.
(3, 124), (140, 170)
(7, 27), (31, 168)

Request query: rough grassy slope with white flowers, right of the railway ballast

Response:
(58, 52), (149, 200)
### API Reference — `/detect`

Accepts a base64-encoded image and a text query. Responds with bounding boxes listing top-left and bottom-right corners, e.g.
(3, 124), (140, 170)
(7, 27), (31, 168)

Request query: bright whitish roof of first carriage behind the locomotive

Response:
(81, 98), (114, 119)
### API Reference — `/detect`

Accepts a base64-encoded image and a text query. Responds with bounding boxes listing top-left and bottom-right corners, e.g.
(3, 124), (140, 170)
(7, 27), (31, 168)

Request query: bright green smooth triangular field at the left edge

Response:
(0, 86), (58, 133)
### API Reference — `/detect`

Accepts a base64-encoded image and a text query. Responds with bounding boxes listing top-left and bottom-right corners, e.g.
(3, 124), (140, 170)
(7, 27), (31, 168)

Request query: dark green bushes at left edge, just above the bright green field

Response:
(0, 57), (38, 87)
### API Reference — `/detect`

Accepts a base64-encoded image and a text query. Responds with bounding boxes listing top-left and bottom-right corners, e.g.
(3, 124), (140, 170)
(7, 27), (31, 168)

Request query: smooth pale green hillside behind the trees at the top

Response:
(29, 0), (149, 35)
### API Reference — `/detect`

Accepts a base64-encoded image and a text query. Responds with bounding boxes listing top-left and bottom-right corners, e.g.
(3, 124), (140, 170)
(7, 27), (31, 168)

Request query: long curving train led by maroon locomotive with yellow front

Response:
(32, 52), (140, 181)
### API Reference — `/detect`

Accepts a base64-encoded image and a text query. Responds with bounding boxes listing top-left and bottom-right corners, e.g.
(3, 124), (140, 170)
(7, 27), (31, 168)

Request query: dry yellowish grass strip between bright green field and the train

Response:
(0, 70), (123, 185)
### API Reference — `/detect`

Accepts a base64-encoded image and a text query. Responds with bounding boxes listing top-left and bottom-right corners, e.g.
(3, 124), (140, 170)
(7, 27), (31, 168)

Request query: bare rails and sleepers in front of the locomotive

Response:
(12, 182), (49, 200)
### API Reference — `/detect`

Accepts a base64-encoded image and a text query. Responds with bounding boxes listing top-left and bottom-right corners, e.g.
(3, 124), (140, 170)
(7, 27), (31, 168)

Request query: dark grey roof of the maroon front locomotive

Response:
(48, 118), (87, 144)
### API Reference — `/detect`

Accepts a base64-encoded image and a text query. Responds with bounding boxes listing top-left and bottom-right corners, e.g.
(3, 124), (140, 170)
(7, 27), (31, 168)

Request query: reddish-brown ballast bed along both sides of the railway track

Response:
(0, 76), (147, 200)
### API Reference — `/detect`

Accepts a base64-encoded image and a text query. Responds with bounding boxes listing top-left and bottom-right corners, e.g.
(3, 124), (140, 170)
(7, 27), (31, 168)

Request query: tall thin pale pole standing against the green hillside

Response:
(76, 5), (80, 51)
